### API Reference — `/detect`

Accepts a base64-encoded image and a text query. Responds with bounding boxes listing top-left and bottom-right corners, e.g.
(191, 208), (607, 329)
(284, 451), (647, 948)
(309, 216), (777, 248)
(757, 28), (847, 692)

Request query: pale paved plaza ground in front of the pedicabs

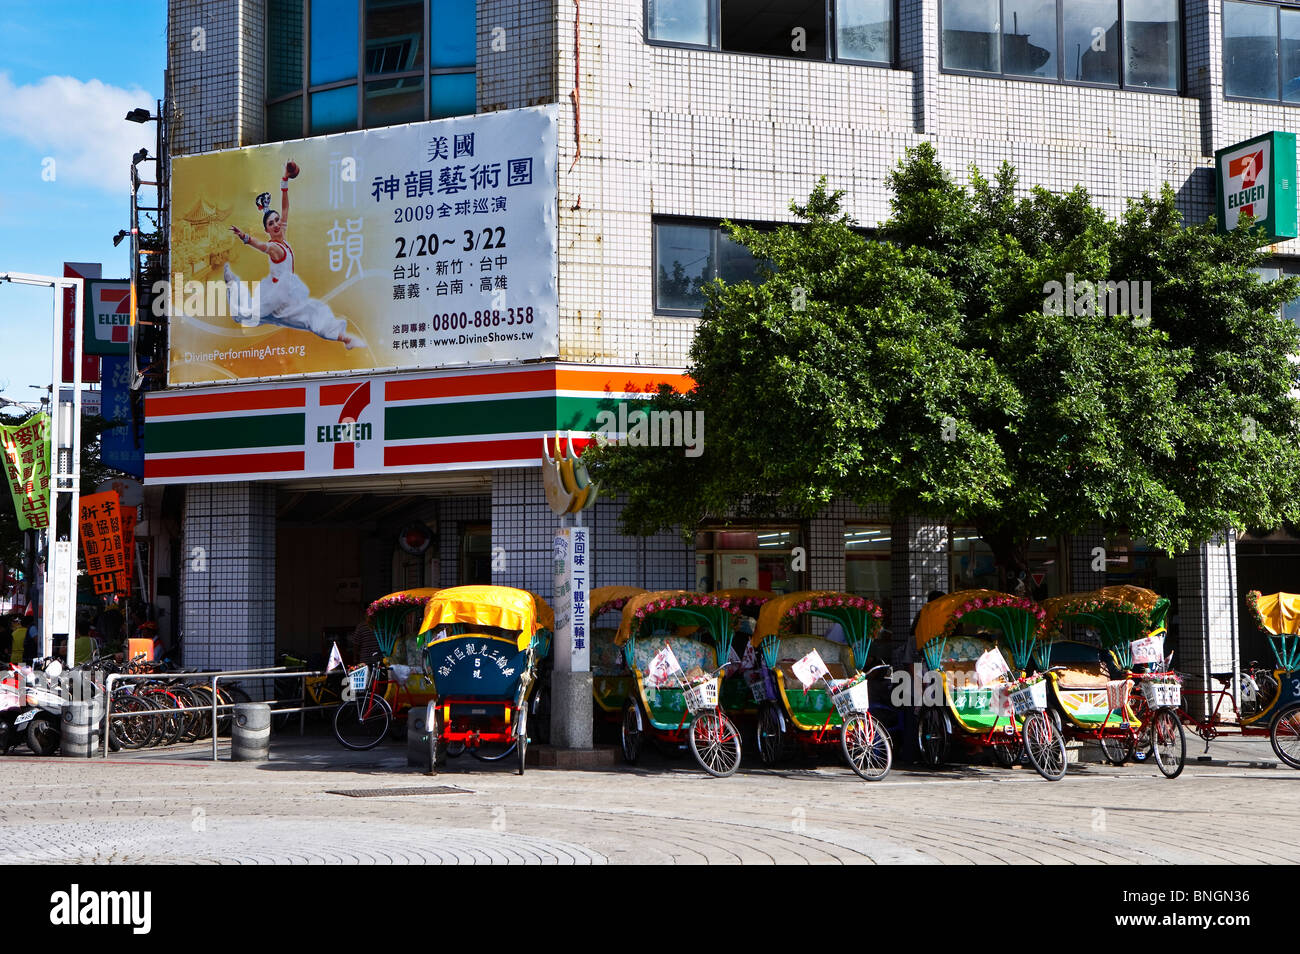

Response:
(0, 737), (1300, 864)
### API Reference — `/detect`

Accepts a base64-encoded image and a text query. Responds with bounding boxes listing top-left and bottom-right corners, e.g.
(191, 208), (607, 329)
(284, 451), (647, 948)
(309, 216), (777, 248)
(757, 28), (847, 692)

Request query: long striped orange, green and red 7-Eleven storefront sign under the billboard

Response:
(144, 363), (690, 483)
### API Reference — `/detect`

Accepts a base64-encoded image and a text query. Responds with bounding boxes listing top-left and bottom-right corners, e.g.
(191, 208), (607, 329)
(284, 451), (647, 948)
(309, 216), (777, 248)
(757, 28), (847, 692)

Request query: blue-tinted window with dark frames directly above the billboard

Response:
(267, 0), (477, 142)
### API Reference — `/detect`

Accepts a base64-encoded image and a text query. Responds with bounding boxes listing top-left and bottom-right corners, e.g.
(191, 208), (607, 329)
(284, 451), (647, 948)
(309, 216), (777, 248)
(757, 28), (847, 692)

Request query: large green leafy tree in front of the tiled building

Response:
(588, 144), (1300, 582)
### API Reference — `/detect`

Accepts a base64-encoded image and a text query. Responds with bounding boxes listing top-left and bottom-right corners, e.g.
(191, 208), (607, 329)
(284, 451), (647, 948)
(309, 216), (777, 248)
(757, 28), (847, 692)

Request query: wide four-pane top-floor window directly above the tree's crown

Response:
(940, 0), (1182, 92)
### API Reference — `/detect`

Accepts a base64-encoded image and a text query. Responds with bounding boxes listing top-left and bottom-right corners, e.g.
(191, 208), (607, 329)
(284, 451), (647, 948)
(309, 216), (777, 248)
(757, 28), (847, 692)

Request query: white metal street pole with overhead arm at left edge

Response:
(0, 272), (85, 667)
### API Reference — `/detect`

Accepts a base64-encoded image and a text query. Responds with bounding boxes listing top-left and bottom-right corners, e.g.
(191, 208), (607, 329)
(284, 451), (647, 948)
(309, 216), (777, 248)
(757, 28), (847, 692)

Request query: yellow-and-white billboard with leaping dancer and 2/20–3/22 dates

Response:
(165, 105), (559, 386)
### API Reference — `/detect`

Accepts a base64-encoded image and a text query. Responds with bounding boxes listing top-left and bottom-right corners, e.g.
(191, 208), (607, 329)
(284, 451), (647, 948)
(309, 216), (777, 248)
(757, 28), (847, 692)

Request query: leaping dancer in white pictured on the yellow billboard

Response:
(224, 162), (365, 351)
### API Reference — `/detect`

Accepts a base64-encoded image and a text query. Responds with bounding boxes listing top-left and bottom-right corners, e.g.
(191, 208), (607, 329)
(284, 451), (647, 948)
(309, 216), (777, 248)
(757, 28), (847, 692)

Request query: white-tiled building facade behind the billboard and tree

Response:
(146, 0), (1300, 701)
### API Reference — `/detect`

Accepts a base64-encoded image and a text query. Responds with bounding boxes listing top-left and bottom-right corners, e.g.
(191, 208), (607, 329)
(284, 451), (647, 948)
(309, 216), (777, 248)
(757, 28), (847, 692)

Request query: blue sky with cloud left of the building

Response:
(0, 0), (166, 402)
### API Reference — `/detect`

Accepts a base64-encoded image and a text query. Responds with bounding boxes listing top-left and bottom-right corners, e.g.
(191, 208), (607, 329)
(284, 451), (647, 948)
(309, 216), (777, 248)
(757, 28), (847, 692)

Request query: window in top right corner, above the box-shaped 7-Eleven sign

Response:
(1223, 0), (1300, 103)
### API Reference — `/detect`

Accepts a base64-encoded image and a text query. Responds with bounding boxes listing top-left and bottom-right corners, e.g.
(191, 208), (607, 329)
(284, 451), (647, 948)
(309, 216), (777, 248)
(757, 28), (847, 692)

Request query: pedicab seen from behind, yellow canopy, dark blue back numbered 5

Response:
(420, 586), (541, 775)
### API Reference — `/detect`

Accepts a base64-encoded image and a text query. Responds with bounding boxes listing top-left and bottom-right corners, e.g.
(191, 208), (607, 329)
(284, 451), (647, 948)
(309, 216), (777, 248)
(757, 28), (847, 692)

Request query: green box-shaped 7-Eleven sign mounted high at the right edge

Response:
(1214, 133), (1297, 243)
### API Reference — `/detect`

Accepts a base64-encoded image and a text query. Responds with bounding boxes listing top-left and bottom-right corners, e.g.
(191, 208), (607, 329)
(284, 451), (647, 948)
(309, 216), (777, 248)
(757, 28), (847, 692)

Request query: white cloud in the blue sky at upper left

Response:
(0, 73), (156, 195)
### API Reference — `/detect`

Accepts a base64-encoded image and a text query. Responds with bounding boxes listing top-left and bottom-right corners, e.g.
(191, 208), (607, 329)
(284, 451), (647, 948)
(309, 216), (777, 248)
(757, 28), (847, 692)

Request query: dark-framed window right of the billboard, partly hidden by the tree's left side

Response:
(653, 221), (758, 315)
